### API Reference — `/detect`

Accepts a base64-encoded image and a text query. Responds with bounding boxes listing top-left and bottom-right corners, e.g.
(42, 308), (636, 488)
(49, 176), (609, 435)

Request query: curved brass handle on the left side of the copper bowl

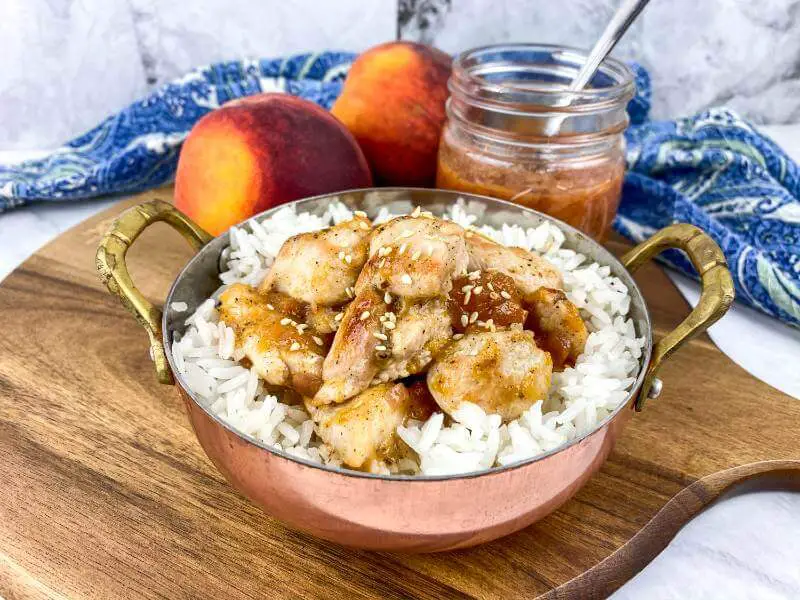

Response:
(95, 200), (213, 383)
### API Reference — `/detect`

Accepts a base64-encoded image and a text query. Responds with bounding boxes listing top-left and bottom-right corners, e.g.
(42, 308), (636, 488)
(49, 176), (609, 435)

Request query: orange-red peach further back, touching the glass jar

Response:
(331, 42), (450, 187)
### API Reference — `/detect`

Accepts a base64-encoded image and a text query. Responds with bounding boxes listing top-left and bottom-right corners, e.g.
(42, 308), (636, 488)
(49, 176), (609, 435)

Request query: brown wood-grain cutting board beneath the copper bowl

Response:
(0, 189), (800, 599)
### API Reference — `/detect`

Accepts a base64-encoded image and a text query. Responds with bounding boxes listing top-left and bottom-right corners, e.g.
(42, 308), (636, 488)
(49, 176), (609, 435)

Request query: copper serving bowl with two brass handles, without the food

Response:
(97, 188), (733, 552)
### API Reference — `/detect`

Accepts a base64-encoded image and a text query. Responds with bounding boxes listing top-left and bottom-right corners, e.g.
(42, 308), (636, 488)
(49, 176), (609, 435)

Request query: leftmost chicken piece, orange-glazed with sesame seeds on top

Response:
(219, 283), (327, 396)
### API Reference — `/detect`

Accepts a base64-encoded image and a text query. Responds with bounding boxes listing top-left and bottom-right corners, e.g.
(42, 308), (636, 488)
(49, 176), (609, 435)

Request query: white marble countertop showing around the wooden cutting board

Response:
(0, 124), (800, 600)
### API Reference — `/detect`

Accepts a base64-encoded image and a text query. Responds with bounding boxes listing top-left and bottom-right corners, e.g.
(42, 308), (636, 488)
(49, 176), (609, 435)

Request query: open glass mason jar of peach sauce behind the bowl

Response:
(436, 44), (635, 241)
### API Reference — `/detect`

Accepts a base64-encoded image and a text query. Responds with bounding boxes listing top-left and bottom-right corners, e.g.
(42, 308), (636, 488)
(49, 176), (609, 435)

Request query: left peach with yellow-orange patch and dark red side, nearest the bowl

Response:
(175, 93), (372, 235)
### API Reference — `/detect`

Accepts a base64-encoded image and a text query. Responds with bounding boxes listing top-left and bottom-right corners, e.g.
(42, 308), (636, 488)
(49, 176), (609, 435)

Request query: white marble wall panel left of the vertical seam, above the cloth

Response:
(0, 0), (397, 150)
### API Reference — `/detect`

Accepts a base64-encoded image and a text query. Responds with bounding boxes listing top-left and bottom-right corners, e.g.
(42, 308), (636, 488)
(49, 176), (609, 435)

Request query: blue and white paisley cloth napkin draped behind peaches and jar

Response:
(0, 52), (800, 327)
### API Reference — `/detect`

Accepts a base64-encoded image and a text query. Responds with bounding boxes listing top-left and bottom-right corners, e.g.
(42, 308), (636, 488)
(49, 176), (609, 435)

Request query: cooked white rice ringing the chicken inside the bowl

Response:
(172, 201), (644, 475)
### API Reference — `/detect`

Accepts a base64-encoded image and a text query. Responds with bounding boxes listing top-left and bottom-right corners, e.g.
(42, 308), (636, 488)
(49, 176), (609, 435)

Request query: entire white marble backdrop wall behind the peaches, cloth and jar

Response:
(0, 0), (800, 150)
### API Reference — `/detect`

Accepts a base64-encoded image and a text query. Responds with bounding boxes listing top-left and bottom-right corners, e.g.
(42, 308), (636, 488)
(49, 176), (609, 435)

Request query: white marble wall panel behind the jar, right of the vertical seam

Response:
(400, 0), (800, 123)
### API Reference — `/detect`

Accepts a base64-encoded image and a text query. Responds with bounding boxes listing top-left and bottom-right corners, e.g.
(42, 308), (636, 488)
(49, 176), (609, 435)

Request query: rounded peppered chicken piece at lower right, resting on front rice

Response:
(428, 328), (553, 422)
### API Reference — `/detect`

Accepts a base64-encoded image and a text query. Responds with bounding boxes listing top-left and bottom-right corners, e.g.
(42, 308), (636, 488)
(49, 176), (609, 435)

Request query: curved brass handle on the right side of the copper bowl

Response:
(620, 223), (734, 411)
